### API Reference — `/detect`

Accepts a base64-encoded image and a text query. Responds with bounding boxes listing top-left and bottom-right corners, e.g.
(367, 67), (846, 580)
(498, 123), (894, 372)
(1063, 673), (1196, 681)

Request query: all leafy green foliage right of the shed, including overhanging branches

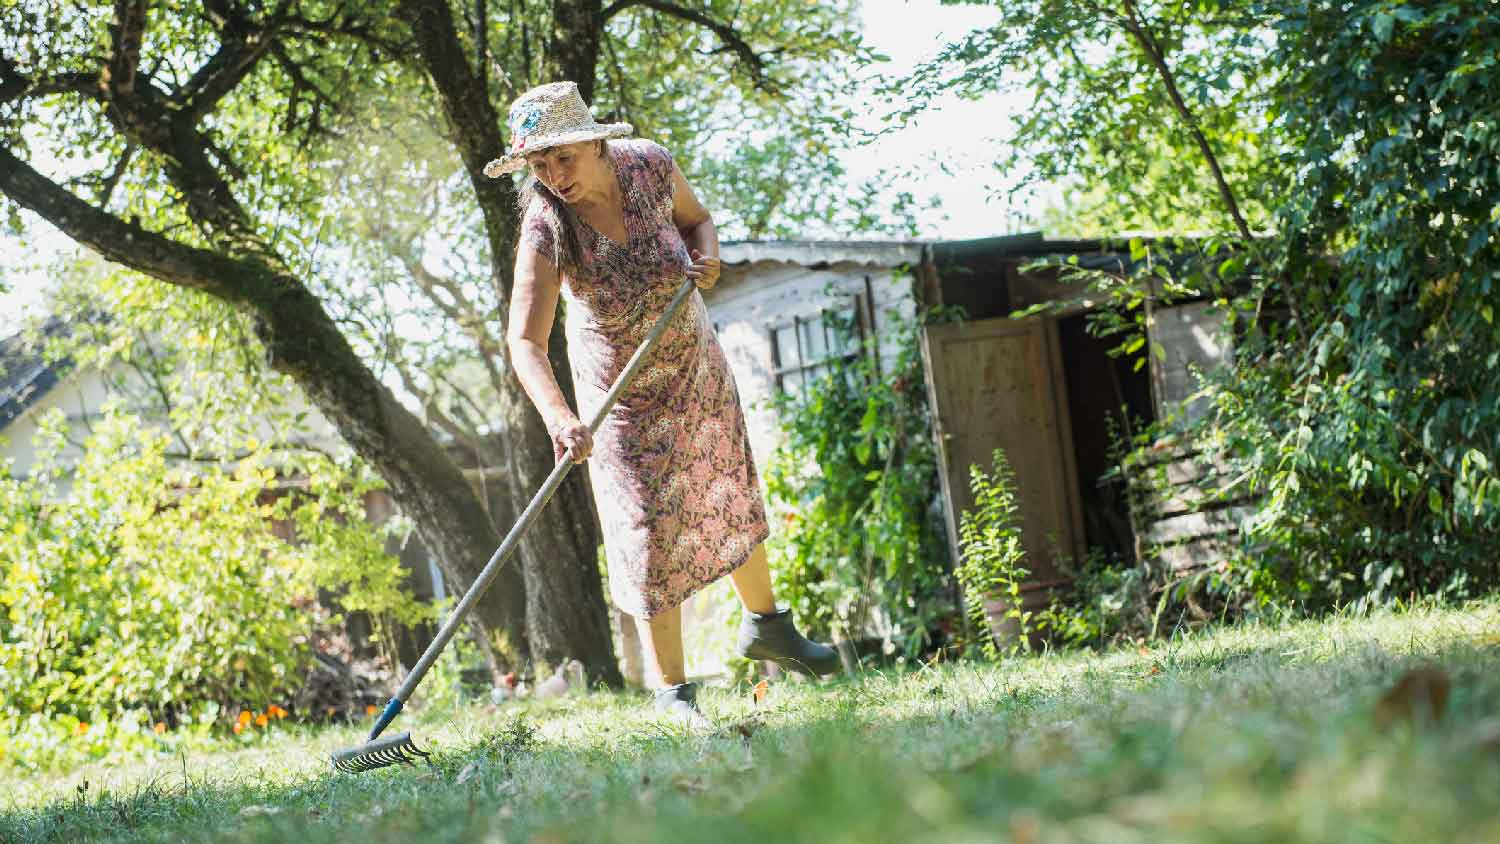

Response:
(915, 0), (1500, 620)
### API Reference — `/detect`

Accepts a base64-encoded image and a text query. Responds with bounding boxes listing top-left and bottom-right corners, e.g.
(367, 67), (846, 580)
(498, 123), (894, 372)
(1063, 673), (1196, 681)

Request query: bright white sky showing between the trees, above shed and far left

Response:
(0, 0), (1026, 334)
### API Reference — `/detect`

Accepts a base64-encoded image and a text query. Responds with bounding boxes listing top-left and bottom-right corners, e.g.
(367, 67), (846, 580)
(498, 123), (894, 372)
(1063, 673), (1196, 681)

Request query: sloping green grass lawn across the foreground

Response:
(0, 601), (1500, 844)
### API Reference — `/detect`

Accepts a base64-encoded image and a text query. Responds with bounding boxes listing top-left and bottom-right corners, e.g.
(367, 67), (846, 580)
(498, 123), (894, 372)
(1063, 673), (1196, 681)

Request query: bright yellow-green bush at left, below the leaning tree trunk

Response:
(0, 408), (426, 733)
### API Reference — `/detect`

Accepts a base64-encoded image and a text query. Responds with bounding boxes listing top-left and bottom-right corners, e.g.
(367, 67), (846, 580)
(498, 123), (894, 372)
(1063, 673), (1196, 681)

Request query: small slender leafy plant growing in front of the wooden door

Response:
(954, 448), (1031, 660)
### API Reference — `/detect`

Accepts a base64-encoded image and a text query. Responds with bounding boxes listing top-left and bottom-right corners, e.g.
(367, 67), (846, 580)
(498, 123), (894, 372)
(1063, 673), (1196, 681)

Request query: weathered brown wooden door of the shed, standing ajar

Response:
(923, 318), (1085, 609)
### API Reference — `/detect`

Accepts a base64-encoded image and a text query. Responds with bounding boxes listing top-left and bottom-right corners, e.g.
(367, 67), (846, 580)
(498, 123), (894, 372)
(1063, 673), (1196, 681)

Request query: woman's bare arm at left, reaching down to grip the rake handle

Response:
(506, 246), (594, 463)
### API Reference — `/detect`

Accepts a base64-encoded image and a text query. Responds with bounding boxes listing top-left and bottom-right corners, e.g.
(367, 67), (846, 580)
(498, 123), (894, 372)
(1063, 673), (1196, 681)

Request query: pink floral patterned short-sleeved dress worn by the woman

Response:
(521, 139), (768, 618)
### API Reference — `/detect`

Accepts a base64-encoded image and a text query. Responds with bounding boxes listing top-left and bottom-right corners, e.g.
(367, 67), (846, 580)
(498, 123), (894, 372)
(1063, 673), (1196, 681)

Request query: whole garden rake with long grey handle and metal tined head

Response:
(332, 279), (696, 774)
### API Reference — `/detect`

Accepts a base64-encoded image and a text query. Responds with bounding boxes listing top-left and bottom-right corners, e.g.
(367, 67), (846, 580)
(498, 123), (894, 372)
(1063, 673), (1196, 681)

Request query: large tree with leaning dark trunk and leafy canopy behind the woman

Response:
(0, 0), (870, 679)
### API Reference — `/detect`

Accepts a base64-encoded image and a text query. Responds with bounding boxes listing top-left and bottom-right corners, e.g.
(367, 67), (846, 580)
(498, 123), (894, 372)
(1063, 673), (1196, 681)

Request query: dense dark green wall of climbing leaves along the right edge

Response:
(1196, 0), (1500, 606)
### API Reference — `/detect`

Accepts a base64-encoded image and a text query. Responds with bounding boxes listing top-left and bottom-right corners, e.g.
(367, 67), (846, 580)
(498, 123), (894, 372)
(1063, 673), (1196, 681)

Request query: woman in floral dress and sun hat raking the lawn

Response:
(485, 82), (839, 726)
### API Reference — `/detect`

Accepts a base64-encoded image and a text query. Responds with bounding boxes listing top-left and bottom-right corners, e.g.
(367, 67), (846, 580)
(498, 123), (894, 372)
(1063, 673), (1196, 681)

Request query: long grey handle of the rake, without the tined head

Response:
(369, 279), (696, 741)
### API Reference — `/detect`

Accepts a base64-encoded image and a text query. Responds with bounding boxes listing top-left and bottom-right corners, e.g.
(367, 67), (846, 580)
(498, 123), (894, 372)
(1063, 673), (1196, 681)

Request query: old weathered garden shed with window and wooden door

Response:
(705, 234), (1229, 617)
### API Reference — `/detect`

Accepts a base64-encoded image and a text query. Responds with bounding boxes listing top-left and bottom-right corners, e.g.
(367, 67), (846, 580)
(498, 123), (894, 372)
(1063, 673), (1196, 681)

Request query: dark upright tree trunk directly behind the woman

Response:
(401, 0), (621, 687)
